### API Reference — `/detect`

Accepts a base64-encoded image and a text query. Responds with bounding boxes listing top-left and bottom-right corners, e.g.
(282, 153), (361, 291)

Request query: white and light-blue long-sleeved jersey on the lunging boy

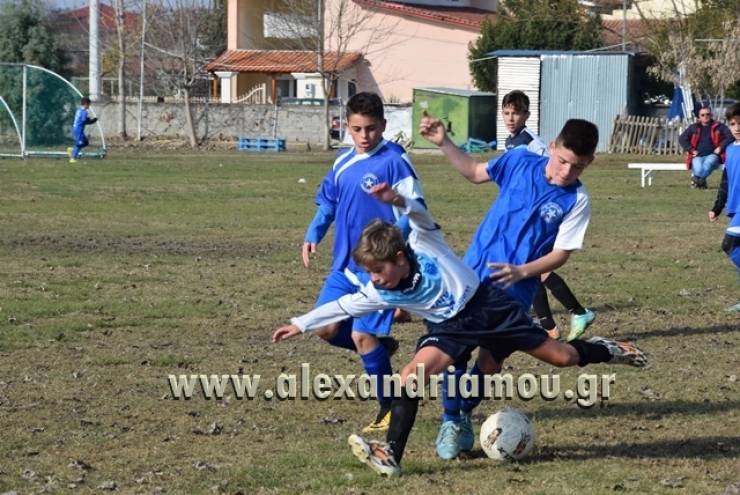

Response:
(291, 197), (480, 332)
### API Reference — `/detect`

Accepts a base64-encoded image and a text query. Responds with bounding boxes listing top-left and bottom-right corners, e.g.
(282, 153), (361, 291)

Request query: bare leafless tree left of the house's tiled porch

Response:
(145, 0), (225, 148)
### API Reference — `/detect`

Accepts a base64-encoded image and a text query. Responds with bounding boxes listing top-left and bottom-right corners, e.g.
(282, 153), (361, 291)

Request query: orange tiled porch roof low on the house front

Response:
(206, 50), (362, 73)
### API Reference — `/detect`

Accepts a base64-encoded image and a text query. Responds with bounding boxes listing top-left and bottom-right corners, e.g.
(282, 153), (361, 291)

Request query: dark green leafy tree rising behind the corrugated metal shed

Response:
(468, 0), (603, 91)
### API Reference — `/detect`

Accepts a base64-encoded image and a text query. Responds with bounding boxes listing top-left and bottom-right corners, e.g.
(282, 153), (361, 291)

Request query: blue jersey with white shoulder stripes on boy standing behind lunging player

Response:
(316, 140), (423, 272)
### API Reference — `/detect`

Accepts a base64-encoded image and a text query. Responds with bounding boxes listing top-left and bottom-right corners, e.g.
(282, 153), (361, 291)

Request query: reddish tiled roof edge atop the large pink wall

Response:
(354, 0), (496, 31)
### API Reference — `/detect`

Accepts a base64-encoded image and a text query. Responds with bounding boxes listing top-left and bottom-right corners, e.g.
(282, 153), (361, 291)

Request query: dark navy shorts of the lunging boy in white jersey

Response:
(416, 282), (549, 363)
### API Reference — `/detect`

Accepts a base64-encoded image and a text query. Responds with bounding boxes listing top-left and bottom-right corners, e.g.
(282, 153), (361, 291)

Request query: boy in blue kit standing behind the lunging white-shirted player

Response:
(302, 93), (423, 431)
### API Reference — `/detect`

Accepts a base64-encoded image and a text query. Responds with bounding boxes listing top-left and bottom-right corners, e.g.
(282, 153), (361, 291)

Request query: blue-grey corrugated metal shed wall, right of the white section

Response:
(540, 54), (630, 152)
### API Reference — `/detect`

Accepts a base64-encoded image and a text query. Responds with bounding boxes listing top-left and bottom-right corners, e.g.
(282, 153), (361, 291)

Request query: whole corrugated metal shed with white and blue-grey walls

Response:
(488, 50), (633, 152)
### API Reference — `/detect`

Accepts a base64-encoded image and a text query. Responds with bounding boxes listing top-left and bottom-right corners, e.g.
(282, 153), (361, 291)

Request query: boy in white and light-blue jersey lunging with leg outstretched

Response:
(272, 184), (647, 476)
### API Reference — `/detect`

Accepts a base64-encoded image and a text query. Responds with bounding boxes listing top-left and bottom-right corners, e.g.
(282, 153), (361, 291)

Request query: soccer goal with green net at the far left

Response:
(0, 62), (106, 158)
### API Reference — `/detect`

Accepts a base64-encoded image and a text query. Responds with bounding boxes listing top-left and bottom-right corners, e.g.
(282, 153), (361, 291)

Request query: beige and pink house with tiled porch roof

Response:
(206, 0), (496, 103)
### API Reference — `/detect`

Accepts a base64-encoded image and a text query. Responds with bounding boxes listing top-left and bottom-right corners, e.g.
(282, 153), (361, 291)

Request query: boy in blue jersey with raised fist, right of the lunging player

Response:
(419, 115), (598, 459)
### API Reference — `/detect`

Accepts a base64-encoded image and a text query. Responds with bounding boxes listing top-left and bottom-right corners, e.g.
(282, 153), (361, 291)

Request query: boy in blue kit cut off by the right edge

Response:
(709, 103), (740, 312)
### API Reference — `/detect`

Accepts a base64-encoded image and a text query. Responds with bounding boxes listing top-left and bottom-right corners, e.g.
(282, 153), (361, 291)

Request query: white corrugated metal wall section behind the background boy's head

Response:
(496, 57), (540, 150)
